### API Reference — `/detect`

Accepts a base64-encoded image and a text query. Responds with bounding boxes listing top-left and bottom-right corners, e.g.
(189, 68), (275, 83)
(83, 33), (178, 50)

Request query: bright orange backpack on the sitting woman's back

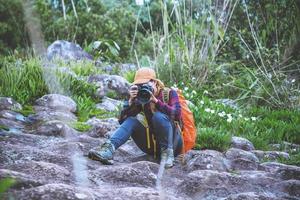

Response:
(163, 88), (197, 153)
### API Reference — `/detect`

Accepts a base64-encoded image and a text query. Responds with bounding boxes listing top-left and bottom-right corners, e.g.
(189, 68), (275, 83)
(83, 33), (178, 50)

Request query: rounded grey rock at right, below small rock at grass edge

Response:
(225, 148), (259, 170)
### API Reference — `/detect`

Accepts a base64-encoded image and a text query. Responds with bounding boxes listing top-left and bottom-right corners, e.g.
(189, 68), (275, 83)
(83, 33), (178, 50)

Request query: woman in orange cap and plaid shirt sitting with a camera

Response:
(89, 68), (182, 168)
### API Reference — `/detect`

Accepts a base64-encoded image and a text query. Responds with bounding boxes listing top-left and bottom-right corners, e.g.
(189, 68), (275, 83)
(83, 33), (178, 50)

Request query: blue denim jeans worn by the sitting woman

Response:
(110, 111), (182, 156)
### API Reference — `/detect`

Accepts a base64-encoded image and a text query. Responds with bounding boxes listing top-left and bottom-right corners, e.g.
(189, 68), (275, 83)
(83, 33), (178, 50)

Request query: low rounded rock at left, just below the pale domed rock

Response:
(31, 120), (76, 137)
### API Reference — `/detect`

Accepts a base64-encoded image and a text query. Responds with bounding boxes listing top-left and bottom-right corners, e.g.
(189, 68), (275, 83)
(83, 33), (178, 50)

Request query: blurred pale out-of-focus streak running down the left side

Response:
(22, 0), (89, 187)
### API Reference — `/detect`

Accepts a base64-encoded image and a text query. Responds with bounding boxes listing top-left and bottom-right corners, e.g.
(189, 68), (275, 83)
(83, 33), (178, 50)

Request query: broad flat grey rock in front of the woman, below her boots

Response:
(89, 161), (159, 187)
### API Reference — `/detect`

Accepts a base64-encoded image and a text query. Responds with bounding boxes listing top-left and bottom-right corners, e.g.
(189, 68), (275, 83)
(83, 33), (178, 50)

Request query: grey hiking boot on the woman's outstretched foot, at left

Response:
(88, 140), (115, 165)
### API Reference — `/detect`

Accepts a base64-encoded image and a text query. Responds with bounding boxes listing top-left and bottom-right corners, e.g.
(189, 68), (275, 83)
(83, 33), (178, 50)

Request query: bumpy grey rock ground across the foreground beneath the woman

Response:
(0, 97), (300, 200)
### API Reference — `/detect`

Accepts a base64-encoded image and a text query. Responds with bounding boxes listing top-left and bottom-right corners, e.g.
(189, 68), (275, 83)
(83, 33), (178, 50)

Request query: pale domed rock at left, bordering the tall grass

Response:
(36, 94), (76, 112)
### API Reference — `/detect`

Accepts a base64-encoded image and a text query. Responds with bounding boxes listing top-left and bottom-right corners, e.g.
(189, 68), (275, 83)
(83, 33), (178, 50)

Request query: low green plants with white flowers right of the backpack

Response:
(183, 87), (300, 150)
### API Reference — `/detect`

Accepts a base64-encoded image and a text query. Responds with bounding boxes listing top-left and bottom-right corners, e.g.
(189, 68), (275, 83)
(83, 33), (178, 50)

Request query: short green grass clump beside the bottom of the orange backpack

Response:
(196, 127), (231, 151)
